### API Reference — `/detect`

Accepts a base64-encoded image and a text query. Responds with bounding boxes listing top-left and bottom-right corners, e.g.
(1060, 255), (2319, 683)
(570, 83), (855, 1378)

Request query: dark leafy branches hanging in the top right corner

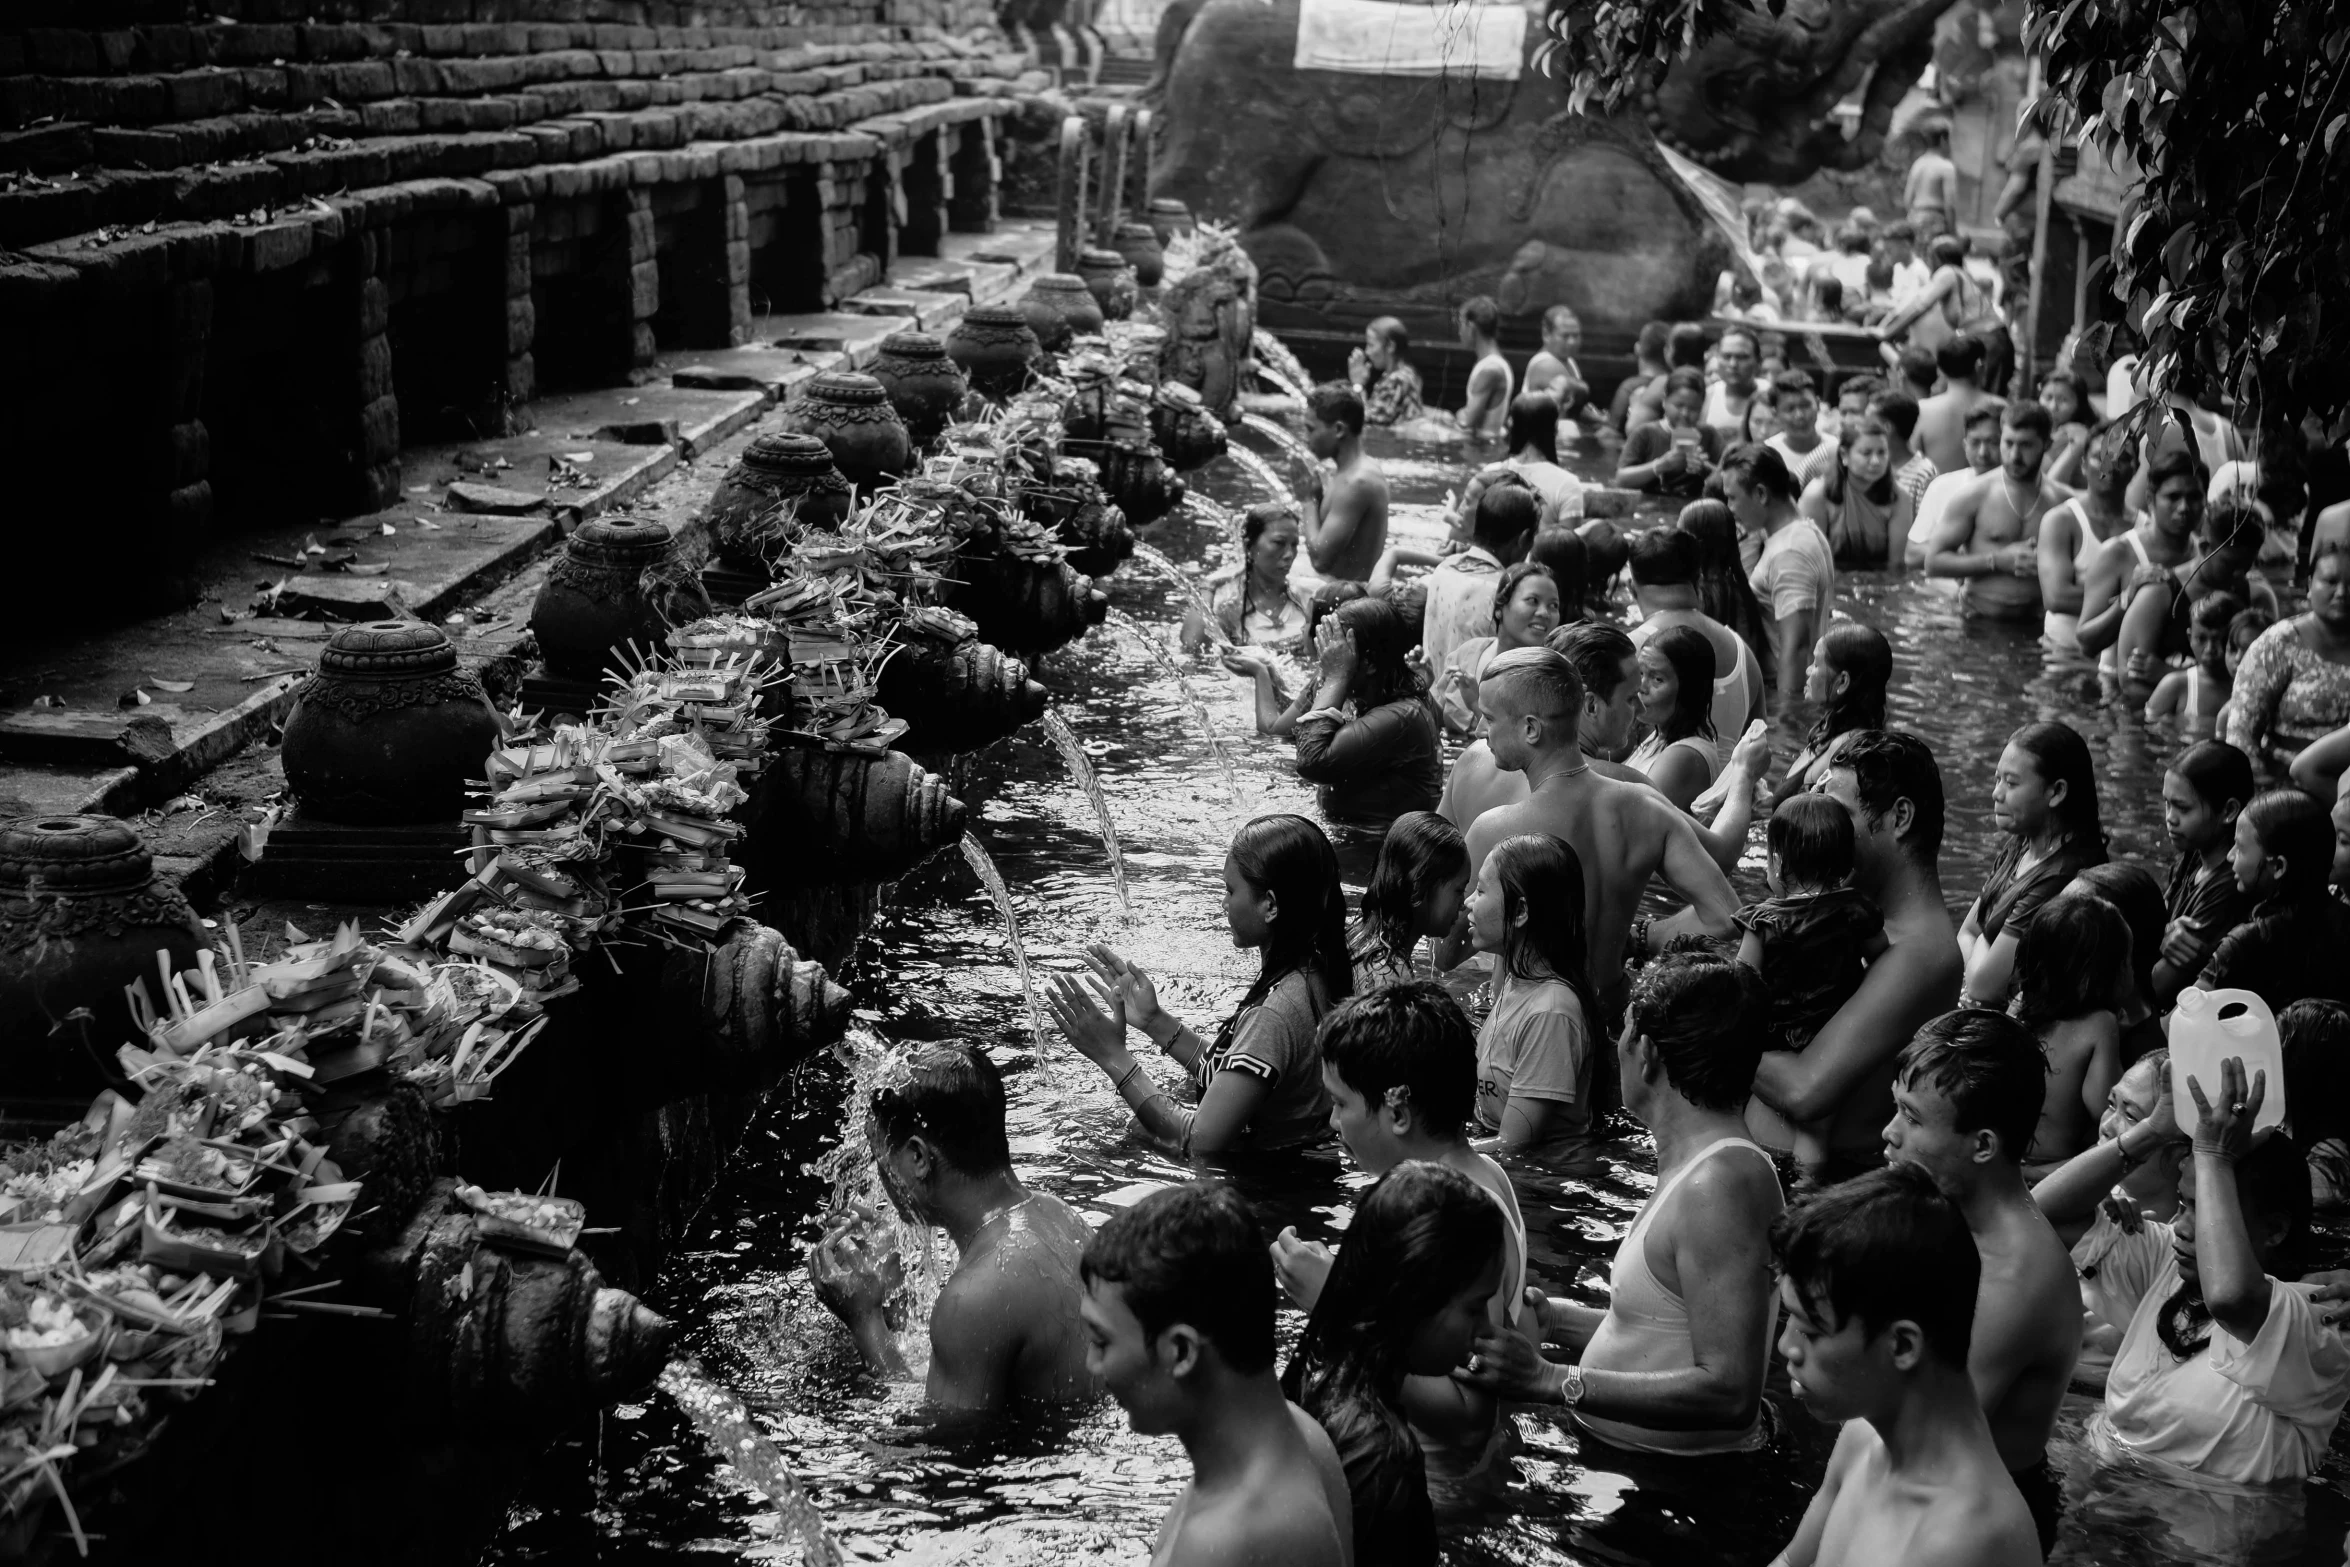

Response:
(2026, 0), (2350, 430)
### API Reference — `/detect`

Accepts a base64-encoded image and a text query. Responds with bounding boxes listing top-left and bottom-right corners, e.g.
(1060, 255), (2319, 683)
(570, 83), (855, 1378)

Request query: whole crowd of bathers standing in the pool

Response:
(811, 312), (2350, 1567)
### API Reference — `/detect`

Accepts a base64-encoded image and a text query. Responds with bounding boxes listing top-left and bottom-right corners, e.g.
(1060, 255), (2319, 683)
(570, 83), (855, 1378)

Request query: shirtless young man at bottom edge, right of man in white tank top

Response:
(1770, 1168), (2040, 1567)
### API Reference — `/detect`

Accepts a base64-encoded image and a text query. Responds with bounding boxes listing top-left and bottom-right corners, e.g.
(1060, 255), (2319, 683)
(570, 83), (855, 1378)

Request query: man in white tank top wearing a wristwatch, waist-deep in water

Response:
(1455, 954), (1784, 1454)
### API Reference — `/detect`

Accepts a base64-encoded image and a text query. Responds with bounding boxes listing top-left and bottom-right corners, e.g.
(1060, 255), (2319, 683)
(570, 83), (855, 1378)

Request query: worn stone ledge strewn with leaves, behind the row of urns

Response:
(0, 221), (1053, 907)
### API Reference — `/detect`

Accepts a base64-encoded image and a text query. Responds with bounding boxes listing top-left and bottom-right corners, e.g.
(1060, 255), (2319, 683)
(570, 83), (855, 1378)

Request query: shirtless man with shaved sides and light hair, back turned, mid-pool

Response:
(1455, 648), (1737, 1013)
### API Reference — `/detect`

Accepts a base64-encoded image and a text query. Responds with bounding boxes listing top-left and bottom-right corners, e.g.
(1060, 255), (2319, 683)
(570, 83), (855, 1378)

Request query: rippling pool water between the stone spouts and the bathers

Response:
(489, 422), (2350, 1567)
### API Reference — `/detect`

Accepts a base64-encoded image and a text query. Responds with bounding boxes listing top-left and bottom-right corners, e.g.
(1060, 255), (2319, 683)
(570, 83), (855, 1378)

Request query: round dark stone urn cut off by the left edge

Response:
(0, 815), (207, 1092)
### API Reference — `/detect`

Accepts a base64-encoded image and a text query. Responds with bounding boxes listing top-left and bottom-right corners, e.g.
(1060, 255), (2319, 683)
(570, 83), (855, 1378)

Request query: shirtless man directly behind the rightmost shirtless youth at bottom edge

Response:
(1885, 1010), (2082, 1551)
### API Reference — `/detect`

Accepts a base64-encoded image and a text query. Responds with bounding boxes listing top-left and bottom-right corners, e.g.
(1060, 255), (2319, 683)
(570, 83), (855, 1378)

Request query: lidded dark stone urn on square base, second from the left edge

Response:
(284, 620), (501, 825)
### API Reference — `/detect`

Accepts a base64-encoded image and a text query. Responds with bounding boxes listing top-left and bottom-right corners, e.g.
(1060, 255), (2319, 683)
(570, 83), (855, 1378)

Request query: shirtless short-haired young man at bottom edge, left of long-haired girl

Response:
(1083, 1182), (1354, 1567)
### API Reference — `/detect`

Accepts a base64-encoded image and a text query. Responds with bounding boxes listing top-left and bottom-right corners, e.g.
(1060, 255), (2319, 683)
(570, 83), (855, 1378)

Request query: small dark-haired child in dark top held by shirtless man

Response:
(1737, 794), (1885, 1050)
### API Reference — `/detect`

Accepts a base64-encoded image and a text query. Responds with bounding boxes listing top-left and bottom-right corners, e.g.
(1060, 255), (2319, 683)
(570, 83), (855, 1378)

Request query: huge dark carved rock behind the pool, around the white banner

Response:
(1152, 0), (1953, 331)
